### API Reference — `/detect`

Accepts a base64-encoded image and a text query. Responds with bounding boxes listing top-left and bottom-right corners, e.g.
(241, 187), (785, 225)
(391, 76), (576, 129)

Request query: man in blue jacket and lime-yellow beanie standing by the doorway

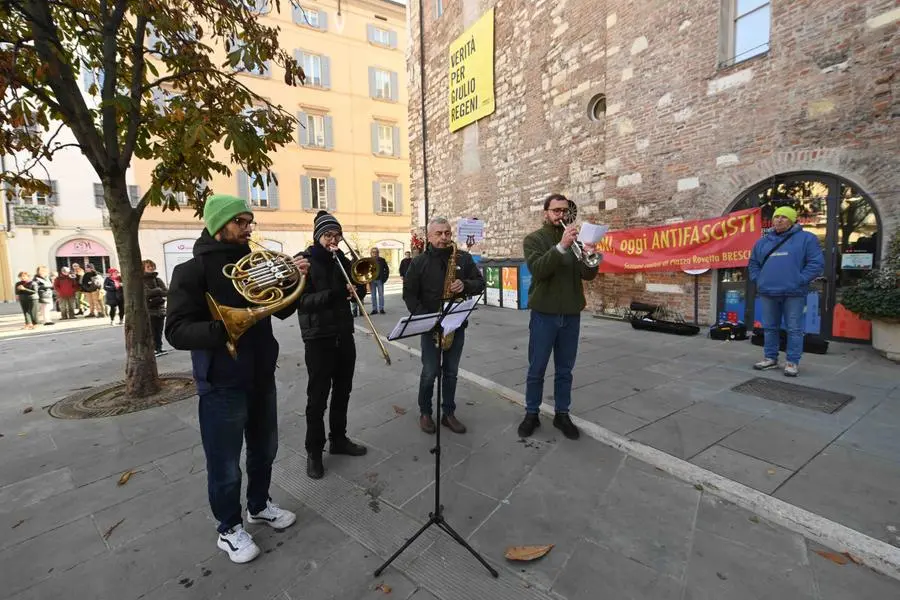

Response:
(748, 206), (825, 377)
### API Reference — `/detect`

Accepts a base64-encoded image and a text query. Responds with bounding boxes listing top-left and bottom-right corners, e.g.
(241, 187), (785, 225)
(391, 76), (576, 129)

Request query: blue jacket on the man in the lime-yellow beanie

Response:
(748, 225), (825, 296)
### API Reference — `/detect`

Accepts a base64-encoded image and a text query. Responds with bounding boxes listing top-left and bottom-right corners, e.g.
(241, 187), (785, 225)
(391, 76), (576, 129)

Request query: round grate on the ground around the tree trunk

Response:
(50, 373), (197, 419)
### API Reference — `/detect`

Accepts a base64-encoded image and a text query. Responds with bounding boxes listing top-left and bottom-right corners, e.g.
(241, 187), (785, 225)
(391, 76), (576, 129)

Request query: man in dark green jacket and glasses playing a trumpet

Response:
(518, 194), (597, 440)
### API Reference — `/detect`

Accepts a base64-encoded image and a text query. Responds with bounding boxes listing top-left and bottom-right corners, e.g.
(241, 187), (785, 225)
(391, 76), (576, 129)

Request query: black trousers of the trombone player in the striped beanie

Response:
(305, 333), (356, 454)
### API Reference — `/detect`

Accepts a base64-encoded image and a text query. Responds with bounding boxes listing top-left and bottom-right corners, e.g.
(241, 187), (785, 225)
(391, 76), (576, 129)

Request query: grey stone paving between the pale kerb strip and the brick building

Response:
(368, 298), (900, 547)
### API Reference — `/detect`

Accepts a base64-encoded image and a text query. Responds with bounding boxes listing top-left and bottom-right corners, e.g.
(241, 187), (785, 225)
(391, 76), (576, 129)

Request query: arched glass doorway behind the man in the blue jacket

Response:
(717, 172), (881, 342)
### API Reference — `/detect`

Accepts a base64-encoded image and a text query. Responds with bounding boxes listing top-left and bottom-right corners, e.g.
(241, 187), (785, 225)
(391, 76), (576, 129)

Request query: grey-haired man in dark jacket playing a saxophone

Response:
(403, 217), (484, 433)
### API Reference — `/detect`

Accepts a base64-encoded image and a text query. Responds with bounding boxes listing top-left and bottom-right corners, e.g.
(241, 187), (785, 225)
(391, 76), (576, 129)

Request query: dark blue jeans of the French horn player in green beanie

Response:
(200, 380), (278, 533)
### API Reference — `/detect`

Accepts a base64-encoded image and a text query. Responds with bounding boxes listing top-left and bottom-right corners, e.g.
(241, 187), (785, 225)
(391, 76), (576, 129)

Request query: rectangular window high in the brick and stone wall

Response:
(720, 0), (772, 66)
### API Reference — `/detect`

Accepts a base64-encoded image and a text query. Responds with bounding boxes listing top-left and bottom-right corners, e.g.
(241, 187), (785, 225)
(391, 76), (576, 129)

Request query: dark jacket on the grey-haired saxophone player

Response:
(403, 244), (484, 314)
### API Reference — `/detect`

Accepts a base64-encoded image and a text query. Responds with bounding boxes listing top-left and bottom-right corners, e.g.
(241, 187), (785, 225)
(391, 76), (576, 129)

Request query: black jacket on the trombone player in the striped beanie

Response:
(297, 243), (366, 342)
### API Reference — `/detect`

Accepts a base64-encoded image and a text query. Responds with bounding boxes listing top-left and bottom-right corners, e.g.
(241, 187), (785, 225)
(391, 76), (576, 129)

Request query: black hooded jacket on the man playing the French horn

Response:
(165, 229), (295, 394)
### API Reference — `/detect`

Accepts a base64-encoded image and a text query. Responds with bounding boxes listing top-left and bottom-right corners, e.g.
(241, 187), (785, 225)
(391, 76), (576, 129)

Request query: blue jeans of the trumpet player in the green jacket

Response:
(525, 310), (581, 414)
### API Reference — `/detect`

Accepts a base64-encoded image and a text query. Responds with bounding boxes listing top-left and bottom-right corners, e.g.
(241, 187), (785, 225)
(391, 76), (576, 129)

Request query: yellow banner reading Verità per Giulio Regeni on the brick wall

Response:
(449, 8), (495, 131)
